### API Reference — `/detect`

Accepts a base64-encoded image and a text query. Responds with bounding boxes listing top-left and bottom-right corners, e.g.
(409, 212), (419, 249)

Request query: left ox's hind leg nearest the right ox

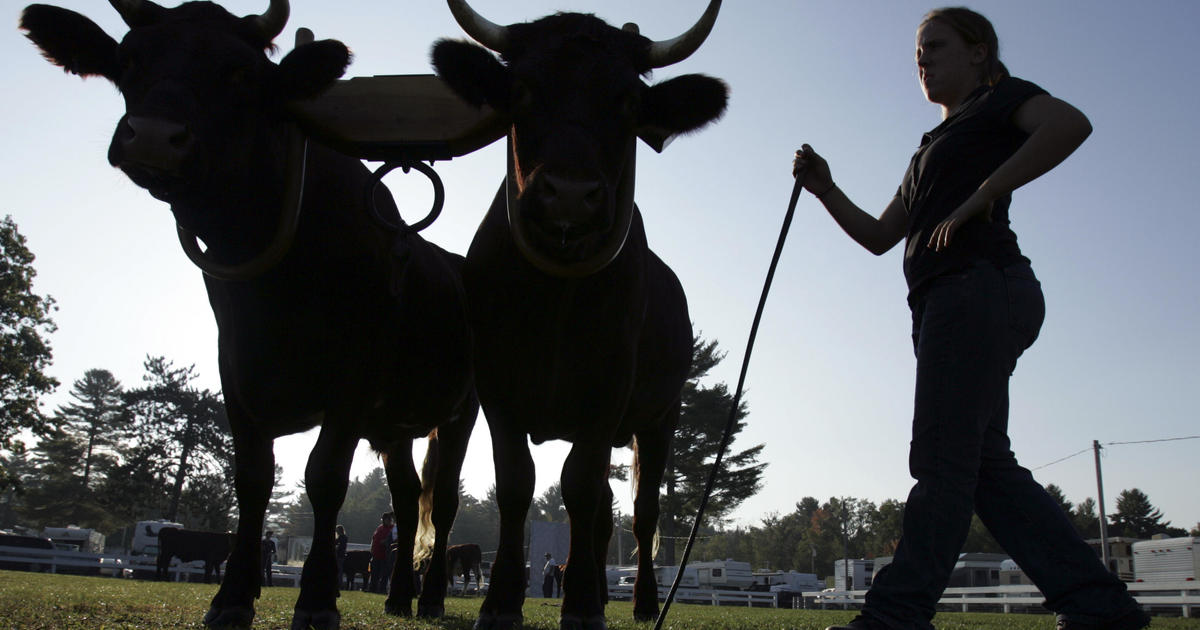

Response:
(416, 396), (479, 617)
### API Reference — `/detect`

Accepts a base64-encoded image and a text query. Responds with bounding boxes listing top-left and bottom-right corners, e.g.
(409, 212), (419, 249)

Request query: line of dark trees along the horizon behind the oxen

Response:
(0, 212), (1200, 575)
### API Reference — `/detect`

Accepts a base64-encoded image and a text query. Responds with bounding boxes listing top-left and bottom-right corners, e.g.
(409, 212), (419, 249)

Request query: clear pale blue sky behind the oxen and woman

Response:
(0, 0), (1200, 535)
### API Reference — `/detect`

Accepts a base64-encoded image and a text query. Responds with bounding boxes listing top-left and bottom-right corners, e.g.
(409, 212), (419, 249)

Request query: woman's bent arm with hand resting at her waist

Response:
(929, 94), (1092, 251)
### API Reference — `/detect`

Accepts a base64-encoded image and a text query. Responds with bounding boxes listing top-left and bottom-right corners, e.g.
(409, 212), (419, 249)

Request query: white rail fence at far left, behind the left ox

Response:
(0, 545), (300, 587)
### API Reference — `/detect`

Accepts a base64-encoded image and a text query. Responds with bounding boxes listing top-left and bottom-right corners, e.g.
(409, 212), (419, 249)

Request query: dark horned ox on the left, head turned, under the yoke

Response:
(22, 0), (479, 628)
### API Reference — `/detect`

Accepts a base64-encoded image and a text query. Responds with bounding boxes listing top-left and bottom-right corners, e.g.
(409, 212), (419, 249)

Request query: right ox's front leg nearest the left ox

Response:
(475, 418), (535, 630)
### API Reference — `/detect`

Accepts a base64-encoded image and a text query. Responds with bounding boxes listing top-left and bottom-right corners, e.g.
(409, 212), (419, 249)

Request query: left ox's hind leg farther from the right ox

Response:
(383, 440), (421, 617)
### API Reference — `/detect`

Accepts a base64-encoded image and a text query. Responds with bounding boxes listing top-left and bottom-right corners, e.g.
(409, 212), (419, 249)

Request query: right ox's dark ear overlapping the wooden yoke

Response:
(430, 40), (509, 112)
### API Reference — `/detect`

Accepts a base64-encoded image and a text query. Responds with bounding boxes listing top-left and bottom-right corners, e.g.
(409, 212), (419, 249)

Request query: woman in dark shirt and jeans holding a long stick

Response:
(792, 8), (1150, 630)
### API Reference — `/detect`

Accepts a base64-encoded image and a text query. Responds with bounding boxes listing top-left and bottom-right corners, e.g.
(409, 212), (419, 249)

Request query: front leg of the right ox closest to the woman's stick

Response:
(559, 439), (612, 630)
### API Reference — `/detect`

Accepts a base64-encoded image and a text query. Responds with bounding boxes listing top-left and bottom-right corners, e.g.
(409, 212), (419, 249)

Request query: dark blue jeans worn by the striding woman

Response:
(863, 263), (1136, 630)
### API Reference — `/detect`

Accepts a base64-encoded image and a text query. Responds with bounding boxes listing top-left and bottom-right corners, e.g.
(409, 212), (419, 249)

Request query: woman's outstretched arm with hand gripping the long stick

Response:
(792, 144), (907, 256)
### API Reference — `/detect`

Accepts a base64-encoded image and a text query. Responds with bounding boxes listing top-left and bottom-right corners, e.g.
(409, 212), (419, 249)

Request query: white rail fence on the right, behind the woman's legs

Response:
(803, 581), (1200, 617)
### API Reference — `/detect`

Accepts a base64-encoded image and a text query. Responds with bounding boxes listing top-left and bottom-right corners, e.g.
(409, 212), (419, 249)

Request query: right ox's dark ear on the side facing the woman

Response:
(638, 74), (730, 133)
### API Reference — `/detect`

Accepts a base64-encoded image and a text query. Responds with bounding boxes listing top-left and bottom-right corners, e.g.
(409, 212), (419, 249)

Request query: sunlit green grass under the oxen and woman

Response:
(0, 571), (1200, 630)
